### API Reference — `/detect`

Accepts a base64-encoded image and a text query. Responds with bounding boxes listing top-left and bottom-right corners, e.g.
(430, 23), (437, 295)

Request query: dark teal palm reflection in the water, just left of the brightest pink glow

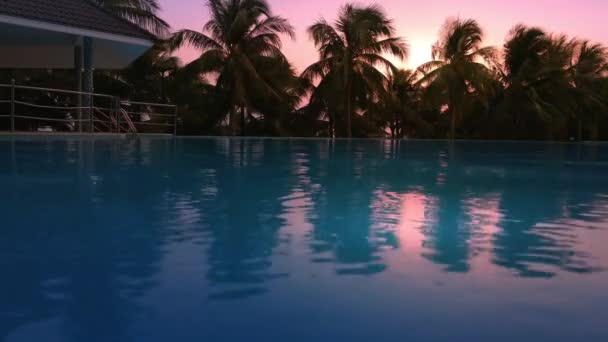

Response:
(308, 142), (395, 275)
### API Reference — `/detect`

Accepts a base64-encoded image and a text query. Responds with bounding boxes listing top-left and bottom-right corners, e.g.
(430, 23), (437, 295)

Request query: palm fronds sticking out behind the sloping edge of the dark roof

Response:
(93, 0), (169, 37)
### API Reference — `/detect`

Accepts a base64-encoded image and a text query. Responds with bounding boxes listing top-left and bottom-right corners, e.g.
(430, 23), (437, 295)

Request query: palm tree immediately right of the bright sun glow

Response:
(419, 19), (496, 139)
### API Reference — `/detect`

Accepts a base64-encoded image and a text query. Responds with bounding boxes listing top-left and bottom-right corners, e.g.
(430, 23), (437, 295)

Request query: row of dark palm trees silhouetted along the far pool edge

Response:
(0, 0), (608, 140)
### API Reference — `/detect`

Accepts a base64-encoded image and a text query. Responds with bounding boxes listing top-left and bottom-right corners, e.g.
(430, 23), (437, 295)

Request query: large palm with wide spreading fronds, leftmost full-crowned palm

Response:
(172, 0), (299, 134)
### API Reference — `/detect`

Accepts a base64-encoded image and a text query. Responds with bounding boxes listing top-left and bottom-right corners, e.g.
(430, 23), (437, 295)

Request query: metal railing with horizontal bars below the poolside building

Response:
(0, 80), (178, 135)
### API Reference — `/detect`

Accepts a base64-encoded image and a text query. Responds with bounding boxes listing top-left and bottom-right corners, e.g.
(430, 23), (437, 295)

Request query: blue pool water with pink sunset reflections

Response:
(0, 138), (608, 342)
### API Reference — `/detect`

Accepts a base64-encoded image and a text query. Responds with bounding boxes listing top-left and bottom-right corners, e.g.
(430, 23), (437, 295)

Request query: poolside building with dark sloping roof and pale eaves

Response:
(0, 0), (155, 92)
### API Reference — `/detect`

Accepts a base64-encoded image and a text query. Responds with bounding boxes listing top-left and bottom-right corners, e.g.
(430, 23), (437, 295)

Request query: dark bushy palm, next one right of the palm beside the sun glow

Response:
(502, 25), (576, 137)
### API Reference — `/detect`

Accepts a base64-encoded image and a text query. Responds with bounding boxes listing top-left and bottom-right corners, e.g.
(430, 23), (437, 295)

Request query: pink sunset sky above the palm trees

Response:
(160, 0), (608, 71)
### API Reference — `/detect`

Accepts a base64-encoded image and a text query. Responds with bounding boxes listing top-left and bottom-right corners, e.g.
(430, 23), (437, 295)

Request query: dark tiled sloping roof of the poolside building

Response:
(0, 0), (154, 40)
